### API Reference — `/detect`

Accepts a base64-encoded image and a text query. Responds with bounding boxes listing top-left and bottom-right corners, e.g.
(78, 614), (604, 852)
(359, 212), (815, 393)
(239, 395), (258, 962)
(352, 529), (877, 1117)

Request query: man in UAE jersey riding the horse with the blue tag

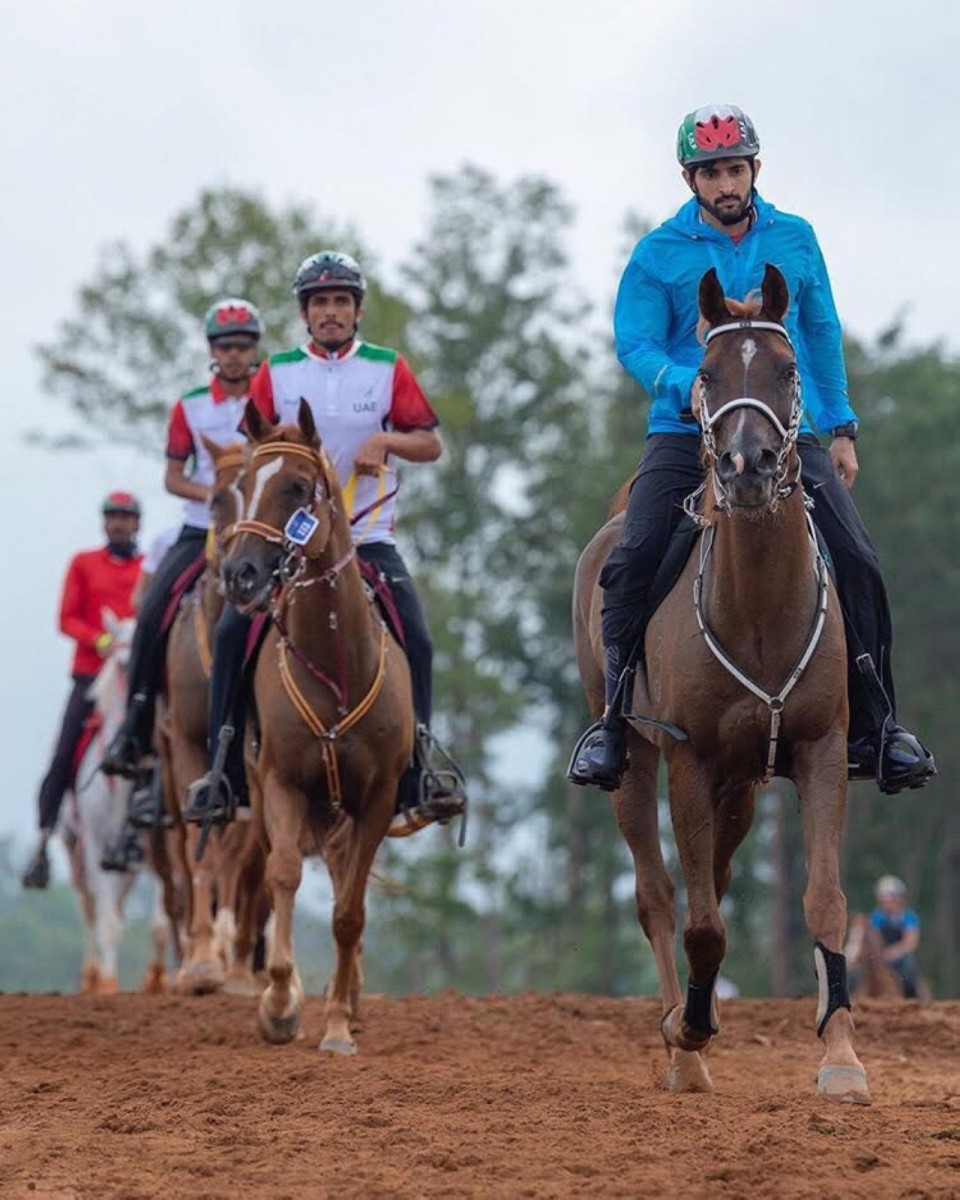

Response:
(185, 250), (464, 830)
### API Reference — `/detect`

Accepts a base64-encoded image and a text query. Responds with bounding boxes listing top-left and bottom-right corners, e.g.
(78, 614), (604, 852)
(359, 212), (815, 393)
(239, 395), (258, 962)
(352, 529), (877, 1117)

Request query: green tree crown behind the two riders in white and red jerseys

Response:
(37, 188), (406, 450)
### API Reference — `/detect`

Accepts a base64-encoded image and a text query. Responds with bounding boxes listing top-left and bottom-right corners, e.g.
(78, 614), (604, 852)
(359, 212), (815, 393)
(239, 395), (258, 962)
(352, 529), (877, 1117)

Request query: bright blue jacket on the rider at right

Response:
(613, 197), (857, 436)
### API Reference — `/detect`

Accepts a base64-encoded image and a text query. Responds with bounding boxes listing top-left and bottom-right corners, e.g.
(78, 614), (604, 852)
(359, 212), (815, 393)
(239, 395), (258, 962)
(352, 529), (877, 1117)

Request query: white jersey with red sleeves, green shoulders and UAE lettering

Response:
(251, 338), (439, 544)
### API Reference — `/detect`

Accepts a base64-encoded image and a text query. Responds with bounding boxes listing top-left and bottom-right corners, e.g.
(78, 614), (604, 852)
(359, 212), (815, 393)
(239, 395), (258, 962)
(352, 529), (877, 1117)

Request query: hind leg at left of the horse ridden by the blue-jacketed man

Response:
(613, 730), (713, 1092)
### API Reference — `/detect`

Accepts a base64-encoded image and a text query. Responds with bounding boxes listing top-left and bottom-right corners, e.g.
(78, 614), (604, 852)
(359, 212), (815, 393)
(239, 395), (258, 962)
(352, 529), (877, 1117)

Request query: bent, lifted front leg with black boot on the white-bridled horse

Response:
(661, 745), (726, 1065)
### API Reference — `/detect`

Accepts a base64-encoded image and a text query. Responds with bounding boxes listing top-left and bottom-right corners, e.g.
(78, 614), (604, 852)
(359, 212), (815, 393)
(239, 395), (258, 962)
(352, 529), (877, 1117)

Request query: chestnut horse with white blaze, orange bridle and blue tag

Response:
(223, 402), (414, 1054)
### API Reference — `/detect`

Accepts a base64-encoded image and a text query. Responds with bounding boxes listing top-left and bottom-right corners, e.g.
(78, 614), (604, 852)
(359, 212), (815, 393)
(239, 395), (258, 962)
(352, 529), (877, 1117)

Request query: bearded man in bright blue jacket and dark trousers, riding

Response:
(570, 106), (936, 793)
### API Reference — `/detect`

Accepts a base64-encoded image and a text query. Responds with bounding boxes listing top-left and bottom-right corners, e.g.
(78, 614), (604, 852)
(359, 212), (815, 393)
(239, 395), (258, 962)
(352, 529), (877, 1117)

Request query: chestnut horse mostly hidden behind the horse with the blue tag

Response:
(157, 438), (262, 995)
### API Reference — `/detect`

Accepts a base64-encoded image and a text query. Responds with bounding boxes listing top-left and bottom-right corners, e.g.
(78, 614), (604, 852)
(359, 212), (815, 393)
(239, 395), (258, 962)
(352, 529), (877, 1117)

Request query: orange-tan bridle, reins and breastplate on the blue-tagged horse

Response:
(229, 442), (394, 810)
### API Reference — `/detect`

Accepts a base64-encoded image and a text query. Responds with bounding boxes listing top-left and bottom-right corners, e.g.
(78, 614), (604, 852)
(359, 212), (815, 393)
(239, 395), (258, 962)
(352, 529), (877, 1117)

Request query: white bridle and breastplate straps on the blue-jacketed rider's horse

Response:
(683, 317), (829, 784)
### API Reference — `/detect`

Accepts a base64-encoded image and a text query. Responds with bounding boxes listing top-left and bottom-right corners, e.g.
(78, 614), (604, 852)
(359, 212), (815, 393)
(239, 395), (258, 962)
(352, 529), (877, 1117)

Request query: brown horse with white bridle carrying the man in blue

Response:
(574, 264), (870, 1103)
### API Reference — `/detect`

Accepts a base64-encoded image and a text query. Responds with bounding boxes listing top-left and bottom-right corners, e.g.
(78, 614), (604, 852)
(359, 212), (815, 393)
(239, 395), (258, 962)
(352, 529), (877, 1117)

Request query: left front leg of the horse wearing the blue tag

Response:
(259, 773), (307, 1043)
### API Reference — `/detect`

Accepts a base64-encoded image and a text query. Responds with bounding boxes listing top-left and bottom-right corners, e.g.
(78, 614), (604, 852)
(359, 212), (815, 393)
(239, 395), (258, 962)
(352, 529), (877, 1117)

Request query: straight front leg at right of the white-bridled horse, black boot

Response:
(793, 730), (871, 1104)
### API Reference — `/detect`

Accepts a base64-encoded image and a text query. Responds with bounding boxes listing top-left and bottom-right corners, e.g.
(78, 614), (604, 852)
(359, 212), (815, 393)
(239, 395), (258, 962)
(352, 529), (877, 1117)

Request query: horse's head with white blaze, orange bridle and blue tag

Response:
(221, 400), (340, 612)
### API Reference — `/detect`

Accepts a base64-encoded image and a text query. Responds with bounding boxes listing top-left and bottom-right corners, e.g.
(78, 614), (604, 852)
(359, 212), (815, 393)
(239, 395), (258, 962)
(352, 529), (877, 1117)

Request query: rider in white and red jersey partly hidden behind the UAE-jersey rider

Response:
(103, 296), (263, 796)
